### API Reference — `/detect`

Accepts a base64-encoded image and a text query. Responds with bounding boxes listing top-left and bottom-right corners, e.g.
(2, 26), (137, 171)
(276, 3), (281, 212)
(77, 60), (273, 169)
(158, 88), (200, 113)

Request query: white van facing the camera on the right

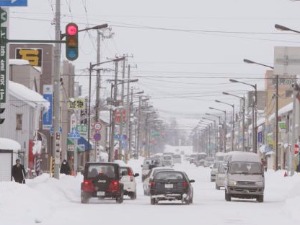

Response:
(224, 151), (265, 202)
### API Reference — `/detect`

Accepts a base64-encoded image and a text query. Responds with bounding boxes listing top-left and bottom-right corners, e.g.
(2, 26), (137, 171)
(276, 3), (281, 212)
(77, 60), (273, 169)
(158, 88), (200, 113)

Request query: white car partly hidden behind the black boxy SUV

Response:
(120, 166), (139, 199)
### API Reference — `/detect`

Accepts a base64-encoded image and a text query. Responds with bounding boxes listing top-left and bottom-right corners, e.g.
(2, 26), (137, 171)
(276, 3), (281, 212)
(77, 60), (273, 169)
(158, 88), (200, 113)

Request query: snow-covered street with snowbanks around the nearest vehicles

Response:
(0, 159), (300, 225)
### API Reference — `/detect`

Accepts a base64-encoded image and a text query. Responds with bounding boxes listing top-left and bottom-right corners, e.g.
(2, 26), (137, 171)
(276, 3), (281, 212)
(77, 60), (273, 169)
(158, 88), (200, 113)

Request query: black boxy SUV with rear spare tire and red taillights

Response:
(81, 163), (124, 203)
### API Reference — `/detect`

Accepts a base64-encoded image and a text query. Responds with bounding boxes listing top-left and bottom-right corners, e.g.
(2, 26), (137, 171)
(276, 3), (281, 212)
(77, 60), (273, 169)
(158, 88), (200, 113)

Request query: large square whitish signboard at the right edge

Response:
(273, 47), (300, 75)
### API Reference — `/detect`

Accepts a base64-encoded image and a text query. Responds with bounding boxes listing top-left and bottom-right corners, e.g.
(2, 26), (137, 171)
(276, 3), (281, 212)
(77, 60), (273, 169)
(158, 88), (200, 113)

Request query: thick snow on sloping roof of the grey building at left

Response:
(9, 81), (50, 112)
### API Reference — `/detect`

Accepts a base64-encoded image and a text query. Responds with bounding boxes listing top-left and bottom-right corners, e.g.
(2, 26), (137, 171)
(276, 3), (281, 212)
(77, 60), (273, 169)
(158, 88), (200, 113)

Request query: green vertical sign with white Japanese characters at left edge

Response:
(0, 8), (8, 103)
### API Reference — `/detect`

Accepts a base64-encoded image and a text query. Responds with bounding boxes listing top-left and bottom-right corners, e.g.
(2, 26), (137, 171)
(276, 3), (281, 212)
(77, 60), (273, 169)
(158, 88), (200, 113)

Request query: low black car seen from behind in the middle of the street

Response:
(149, 170), (195, 205)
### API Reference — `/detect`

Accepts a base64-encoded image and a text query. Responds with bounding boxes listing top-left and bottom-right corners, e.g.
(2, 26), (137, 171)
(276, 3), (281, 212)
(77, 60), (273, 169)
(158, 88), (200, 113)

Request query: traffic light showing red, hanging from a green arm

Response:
(66, 23), (78, 61)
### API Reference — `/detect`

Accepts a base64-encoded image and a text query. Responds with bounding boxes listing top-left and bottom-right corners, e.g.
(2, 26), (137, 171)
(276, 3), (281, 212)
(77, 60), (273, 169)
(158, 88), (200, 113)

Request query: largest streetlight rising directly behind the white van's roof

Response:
(229, 79), (257, 153)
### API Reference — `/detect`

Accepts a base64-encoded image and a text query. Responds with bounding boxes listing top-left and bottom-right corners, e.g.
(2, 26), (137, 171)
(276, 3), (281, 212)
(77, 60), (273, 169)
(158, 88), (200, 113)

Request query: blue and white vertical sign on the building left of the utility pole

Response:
(43, 84), (53, 130)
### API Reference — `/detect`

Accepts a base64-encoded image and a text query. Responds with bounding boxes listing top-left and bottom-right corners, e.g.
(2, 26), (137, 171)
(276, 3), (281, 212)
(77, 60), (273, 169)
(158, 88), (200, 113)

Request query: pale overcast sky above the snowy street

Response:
(10, 0), (300, 131)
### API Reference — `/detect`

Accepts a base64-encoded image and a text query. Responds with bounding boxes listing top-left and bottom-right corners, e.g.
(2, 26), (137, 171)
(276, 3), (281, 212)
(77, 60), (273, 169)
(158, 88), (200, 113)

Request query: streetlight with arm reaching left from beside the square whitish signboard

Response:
(244, 59), (284, 170)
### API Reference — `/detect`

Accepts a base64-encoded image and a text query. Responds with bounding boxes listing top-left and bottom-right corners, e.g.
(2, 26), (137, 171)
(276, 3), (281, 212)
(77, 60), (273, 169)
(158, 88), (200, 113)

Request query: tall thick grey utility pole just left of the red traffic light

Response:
(52, 0), (61, 179)
